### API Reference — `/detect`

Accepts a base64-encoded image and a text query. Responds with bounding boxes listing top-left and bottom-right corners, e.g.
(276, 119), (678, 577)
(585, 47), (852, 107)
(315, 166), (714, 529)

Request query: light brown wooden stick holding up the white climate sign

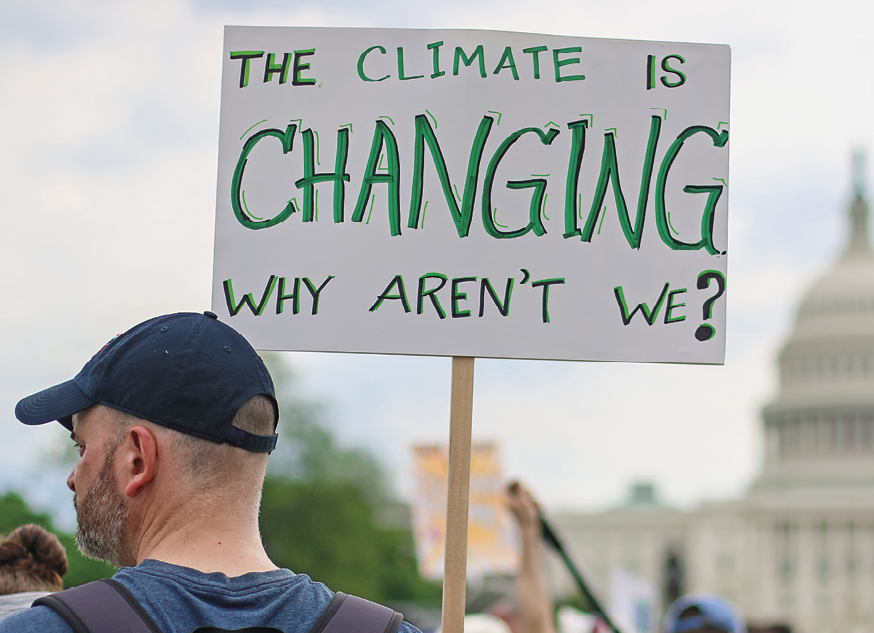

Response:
(443, 356), (474, 633)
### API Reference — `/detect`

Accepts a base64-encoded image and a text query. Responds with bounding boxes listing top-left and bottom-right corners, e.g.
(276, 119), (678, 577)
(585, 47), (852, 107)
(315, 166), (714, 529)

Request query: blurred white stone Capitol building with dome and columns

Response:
(553, 174), (874, 633)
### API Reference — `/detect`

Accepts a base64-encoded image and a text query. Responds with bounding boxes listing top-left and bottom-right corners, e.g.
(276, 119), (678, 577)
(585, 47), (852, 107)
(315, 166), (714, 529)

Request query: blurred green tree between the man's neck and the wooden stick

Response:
(255, 354), (442, 603)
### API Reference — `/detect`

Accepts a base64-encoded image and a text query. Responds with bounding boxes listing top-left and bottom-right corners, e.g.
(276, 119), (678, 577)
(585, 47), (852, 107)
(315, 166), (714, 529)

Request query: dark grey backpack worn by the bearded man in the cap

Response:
(32, 578), (404, 633)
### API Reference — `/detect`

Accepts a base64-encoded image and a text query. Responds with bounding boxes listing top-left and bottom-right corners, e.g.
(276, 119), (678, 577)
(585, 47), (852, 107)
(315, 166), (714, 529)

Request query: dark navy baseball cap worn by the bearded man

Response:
(15, 312), (279, 453)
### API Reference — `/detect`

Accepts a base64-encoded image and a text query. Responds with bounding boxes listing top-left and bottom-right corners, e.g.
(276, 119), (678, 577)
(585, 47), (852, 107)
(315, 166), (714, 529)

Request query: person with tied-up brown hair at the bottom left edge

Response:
(0, 524), (67, 620)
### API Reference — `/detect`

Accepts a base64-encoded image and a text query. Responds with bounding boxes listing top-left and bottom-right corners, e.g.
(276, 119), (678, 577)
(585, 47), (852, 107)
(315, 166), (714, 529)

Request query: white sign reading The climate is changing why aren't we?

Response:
(212, 27), (730, 363)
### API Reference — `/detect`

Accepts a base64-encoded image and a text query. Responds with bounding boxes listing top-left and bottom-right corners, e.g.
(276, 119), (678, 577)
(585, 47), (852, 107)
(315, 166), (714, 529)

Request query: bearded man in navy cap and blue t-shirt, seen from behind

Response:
(0, 312), (416, 633)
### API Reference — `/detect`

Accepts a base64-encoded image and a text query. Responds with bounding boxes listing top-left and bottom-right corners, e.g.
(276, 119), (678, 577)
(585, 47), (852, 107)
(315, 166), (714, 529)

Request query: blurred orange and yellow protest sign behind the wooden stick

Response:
(413, 442), (520, 579)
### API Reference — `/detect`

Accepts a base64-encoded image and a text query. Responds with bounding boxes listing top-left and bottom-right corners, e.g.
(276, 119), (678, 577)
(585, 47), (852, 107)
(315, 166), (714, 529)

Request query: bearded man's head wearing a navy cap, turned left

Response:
(15, 313), (278, 566)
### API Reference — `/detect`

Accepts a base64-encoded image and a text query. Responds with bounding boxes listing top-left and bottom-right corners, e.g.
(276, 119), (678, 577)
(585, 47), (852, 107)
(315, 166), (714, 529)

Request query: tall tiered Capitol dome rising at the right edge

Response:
(753, 169), (874, 491)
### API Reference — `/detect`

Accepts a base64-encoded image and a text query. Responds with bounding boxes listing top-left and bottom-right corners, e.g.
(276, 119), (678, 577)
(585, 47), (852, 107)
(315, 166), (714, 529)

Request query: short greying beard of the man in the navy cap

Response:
(73, 450), (128, 567)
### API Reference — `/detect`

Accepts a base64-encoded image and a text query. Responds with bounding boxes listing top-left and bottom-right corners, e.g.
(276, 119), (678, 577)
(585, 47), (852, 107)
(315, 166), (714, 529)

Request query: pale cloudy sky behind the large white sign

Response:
(0, 0), (874, 528)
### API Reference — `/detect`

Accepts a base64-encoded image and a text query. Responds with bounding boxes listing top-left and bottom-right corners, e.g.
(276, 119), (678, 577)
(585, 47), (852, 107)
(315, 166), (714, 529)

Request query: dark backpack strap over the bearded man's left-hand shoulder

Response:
(32, 578), (161, 633)
